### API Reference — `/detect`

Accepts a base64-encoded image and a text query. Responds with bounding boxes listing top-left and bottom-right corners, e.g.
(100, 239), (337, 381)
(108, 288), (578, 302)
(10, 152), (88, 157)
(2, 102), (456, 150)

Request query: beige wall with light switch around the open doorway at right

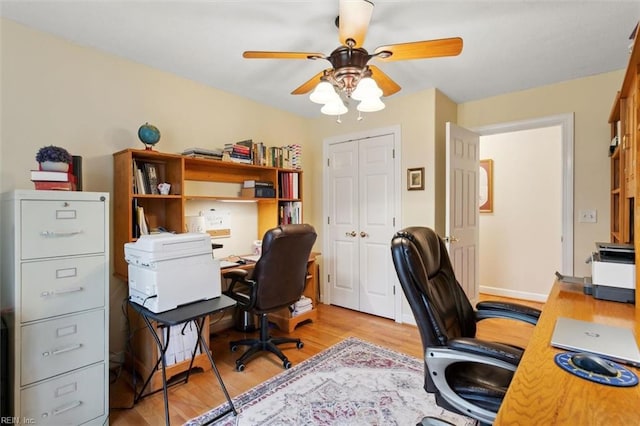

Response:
(458, 70), (624, 280)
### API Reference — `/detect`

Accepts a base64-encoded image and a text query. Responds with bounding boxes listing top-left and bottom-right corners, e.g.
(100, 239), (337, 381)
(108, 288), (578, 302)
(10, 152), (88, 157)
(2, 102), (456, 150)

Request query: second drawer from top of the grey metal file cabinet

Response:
(20, 256), (107, 322)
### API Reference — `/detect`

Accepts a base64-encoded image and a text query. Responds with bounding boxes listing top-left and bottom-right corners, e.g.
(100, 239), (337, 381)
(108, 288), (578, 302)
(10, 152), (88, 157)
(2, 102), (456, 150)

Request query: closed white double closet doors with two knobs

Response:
(326, 134), (397, 318)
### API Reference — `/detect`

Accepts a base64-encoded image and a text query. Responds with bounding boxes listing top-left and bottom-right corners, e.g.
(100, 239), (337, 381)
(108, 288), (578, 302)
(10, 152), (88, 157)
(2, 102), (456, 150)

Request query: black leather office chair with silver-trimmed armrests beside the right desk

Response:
(391, 227), (540, 424)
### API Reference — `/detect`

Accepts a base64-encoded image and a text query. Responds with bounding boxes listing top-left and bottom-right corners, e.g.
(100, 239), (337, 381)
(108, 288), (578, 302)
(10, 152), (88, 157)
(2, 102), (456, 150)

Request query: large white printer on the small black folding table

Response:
(124, 233), (221, 313)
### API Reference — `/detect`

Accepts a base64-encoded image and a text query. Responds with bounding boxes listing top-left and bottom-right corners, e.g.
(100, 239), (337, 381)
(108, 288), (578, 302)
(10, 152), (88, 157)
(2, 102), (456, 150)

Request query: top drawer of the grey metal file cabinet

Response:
(20, 200), (107, 259)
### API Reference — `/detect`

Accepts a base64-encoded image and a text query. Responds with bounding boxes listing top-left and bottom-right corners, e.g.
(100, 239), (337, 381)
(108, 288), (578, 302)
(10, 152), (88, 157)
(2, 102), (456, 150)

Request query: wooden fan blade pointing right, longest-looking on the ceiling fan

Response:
(374, 37), (462, 62)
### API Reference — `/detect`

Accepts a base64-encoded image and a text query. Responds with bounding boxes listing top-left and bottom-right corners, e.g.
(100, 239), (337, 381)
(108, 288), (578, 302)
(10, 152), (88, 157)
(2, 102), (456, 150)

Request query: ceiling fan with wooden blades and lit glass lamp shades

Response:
(242, 0), (462, 115)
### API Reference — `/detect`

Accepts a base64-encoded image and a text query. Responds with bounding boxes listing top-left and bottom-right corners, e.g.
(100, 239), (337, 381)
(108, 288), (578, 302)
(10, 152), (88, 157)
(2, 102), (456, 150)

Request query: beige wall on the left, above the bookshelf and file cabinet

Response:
(0, 19), (312, 352)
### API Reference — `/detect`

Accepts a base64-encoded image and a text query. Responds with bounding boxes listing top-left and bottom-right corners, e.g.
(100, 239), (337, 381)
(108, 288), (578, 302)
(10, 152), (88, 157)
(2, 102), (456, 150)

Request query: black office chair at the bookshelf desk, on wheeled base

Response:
(224, 224), (316, 371)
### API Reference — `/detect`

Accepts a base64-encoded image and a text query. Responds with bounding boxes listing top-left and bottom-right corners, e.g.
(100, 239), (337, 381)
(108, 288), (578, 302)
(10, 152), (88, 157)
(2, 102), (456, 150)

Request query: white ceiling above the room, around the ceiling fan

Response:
(0, 0), (640, 117)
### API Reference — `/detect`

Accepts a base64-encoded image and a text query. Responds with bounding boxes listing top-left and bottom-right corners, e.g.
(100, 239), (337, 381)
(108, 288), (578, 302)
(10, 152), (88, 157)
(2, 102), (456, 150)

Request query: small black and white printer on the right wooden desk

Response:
(591, 243), (636, 303)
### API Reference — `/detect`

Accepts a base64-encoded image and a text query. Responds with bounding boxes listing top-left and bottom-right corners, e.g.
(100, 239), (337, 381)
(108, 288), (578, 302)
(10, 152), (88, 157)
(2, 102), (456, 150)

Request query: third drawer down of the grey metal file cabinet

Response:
(20, 310), (105, 386)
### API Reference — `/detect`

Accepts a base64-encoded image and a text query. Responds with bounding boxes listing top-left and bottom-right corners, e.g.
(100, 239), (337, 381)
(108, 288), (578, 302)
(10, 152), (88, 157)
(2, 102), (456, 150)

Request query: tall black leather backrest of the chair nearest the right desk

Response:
(391, 226), (476, 350)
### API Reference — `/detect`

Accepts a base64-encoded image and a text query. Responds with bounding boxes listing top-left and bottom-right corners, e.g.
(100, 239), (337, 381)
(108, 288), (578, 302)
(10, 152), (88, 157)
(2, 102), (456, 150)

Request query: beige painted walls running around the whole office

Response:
(0, 19), (622, 338)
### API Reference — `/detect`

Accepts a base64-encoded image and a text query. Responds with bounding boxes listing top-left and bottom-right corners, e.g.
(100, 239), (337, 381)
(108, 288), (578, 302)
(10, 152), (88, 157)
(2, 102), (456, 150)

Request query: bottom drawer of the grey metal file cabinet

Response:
(21, 363), (106, 426)
